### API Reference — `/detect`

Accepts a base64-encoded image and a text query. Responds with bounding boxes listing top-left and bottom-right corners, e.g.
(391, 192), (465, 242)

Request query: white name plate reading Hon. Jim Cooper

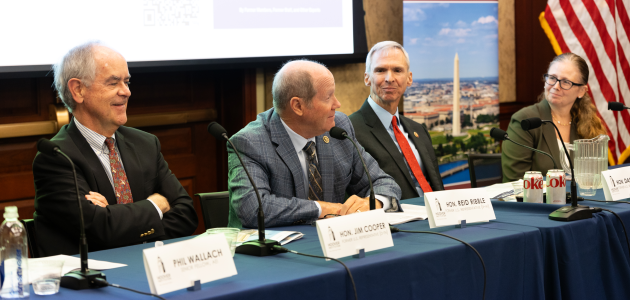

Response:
(316, 209), (394, 258)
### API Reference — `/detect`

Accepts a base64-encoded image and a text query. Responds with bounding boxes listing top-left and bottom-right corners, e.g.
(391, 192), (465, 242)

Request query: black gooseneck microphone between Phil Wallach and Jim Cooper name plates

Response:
(208, 122), (280, 256)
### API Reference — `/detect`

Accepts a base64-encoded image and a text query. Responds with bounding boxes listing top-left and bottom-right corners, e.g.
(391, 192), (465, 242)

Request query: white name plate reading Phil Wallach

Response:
(143, 234), (236, 295)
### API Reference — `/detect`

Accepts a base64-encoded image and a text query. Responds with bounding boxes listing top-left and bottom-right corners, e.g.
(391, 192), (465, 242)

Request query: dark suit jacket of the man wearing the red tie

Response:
(350, 100), (444, 199)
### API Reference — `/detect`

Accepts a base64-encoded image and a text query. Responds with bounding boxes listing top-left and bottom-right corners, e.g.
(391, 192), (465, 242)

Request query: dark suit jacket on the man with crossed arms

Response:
(33, 119), (197, 256)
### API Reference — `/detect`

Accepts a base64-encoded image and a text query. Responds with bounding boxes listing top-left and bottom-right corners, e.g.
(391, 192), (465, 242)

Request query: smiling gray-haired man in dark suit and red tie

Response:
(350, 41), (444, 199)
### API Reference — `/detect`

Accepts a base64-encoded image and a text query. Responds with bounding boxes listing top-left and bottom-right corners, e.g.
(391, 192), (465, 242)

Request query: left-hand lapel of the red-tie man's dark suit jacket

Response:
(361, 100), (415, 189)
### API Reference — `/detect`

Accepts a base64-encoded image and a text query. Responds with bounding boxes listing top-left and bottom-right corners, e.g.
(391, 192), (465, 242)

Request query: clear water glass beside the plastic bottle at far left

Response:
(28, 259), (64, 295)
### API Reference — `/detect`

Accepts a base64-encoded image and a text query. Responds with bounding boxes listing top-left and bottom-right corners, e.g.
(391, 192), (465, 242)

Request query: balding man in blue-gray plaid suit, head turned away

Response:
(228, 60), (401, 227)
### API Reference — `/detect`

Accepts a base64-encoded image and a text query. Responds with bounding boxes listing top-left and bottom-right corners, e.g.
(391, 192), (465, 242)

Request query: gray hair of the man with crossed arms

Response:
(53, 42), (101, 112)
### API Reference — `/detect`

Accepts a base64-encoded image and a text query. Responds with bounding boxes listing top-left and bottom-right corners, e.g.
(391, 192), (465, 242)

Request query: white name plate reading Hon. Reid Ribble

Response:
(424, 188), (496, 228)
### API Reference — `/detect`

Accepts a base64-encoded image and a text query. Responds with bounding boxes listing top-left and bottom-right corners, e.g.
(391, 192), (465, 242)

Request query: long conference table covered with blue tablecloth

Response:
(31, 184), (630, 300)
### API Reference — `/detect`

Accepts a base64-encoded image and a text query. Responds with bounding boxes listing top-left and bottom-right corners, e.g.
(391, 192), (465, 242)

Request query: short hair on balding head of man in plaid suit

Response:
(271, 59), (325, 113)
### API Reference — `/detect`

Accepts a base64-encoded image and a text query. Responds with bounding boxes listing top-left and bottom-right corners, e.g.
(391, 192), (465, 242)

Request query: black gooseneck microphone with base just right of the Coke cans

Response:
(521, 118), (597, 222)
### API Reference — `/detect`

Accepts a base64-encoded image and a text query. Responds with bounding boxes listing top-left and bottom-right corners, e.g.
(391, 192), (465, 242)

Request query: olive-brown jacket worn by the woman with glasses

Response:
(501, 100), (579, 182)
